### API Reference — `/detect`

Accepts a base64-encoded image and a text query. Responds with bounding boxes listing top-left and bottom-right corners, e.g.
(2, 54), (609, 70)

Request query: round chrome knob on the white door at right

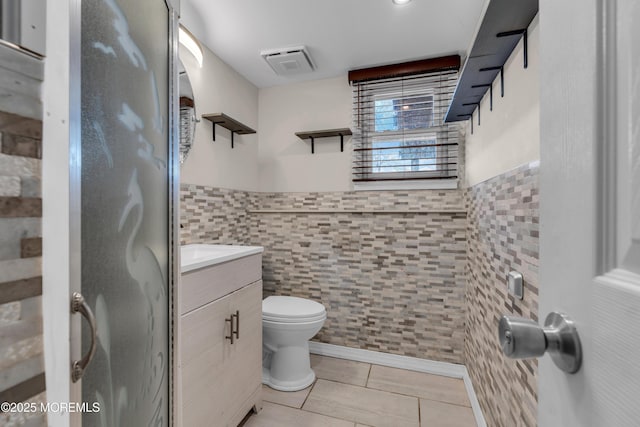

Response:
(498, 312), (582, 374)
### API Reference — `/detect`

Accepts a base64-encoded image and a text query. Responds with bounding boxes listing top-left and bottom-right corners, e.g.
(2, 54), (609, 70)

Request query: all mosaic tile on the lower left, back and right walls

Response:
(182, 163), (539, 427)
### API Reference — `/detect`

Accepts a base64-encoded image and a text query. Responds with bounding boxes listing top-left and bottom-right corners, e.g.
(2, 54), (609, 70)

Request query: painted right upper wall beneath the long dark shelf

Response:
(465, 16), (540, 186)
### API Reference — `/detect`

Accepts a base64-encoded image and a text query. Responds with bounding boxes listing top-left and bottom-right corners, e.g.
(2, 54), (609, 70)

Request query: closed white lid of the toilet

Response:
(262, 296), (326, 322)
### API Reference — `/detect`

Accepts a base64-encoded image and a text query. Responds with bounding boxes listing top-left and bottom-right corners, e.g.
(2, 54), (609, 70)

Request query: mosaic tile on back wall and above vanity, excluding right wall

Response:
(181, 185), (466, 363)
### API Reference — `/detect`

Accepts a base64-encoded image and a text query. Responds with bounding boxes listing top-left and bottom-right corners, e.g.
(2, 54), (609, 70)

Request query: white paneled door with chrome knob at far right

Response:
(538, 0), (640, 427)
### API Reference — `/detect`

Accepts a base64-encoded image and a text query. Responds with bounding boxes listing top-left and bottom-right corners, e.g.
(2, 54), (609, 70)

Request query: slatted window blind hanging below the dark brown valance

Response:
(352, 70), (459, 182)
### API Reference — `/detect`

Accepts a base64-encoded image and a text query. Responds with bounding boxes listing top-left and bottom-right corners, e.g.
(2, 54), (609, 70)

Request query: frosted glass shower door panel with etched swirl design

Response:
(81, 0), (170, 427)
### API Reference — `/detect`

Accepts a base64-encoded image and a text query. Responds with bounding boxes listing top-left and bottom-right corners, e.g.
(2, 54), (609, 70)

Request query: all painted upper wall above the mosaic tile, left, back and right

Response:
(181, 9), (540, 192)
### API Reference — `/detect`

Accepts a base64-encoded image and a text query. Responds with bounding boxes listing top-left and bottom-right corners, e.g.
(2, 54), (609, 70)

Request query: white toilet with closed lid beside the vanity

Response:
(262, 296), (327, 391)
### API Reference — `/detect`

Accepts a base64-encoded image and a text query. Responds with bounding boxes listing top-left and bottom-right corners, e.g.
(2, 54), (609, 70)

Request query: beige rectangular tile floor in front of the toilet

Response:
(243, 355), (476, 427)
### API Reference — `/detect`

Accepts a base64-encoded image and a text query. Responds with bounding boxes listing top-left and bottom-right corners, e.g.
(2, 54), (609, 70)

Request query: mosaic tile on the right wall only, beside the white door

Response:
(464, 163), (539, 427)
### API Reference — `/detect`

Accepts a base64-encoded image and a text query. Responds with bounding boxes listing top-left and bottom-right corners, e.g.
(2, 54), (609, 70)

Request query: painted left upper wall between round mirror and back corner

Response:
(180, 41), (259, 191)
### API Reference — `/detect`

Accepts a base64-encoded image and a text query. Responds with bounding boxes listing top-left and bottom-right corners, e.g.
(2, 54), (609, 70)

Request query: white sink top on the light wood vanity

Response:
(180, 244), (264, 273)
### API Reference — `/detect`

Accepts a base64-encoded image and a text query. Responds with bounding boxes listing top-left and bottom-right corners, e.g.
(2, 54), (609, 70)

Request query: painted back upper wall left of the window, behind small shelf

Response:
(258, 75), (352, 192)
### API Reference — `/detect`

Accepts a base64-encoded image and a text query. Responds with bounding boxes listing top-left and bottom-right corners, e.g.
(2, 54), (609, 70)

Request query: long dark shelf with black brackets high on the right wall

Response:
(445, 0), (538, 124)
